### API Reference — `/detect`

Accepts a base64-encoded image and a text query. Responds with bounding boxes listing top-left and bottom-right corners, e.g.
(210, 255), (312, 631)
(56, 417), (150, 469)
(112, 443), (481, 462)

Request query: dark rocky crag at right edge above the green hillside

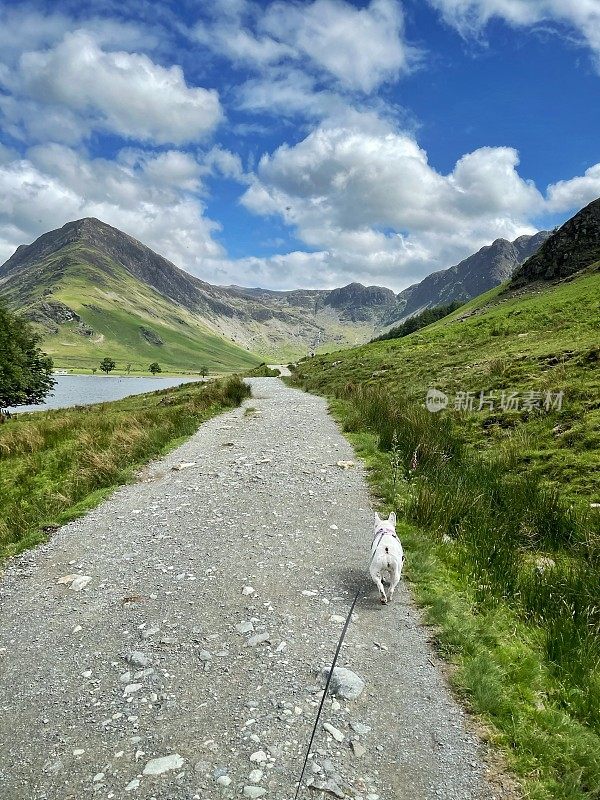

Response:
(510, 198), (600, 288)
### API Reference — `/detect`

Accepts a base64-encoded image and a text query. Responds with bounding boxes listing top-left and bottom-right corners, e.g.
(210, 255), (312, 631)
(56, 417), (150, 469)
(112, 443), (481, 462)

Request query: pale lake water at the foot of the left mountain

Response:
(9, 375), (199, 412)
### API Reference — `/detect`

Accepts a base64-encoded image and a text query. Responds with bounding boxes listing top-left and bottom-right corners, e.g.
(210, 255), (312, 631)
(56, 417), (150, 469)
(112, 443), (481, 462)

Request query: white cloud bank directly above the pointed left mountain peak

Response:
(0, 144), (226, 274)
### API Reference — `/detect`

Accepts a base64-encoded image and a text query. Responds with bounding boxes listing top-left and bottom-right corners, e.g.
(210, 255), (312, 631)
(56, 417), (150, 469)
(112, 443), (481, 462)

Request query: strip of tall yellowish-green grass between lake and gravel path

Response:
(0, 376), (250, 557)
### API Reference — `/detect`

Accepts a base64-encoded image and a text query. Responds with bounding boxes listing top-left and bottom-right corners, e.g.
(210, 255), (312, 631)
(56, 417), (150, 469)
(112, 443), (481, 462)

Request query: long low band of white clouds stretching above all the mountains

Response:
(0, 134), (600, 290)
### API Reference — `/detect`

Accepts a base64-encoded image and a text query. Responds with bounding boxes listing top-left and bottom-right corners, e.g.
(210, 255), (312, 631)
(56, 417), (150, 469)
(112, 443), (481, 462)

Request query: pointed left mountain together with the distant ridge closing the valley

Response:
(0, 218), (404, 368)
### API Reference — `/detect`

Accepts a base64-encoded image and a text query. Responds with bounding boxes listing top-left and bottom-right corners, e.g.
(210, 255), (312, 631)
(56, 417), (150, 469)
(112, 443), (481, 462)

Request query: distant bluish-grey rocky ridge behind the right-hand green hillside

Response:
(388, 231), (550, 325)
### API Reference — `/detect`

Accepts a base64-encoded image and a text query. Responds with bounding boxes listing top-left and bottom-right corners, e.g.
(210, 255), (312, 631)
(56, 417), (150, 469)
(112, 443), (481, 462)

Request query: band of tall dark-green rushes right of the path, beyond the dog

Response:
(338, 385), (600, 726)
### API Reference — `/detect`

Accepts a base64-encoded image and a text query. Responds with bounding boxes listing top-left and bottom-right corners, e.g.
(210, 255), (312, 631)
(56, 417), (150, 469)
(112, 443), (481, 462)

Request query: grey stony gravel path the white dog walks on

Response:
(0, 378), (501, 800)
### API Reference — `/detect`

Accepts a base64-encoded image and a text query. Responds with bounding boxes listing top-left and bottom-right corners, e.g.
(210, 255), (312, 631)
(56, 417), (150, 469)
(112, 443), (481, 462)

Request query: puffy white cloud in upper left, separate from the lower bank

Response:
(4, 31), (223, 144)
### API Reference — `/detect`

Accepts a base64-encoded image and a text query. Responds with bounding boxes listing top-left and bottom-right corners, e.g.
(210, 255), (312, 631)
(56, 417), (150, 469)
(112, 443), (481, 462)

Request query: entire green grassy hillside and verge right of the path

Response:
(296, 269), (600, 800)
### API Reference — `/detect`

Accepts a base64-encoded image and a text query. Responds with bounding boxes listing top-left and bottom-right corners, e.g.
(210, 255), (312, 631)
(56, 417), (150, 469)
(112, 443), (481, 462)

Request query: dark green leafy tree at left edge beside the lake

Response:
(0, 305), (55, 409)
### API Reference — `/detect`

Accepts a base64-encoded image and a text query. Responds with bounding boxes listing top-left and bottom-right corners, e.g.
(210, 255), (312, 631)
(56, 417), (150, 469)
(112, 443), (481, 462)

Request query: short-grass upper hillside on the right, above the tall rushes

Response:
(299, 269), (600, 502)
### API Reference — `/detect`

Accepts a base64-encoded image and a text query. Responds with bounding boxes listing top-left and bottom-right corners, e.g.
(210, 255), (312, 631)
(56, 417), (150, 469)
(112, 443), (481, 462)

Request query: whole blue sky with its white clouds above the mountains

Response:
(0, 0), (600, 290)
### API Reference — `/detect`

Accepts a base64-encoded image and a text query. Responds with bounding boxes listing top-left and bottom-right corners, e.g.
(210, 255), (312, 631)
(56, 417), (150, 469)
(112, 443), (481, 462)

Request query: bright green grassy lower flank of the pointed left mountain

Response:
(2, 244), (260, 372)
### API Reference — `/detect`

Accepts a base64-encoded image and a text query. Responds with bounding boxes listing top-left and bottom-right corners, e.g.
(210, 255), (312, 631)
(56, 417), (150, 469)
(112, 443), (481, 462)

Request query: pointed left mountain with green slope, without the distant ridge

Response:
(0, 229), (259, 372)
